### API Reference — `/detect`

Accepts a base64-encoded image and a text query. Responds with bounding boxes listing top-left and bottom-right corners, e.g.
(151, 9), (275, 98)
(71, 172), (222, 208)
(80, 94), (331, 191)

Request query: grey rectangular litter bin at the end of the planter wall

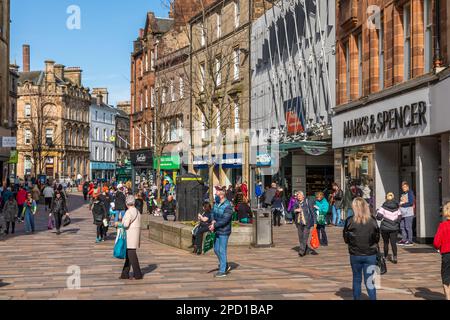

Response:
(253, 209), (273, 248)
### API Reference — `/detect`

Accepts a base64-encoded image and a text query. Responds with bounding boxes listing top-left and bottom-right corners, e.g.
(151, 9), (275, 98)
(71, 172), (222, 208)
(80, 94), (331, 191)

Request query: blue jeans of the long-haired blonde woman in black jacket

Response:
(350, 255), (377, 300)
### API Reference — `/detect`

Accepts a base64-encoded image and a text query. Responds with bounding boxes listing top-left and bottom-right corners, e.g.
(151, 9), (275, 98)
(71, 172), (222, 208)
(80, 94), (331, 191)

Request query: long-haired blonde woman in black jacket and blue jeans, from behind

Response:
(343, 197), (380, 300)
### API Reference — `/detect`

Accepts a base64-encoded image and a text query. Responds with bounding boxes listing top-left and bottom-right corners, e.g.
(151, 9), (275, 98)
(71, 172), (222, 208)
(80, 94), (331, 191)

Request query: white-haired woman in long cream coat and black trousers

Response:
(116, 196), (143, 280)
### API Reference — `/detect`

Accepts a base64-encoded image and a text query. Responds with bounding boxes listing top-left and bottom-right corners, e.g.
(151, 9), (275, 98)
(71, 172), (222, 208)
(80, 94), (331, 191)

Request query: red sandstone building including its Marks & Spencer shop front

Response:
(333, 0), (450, 241)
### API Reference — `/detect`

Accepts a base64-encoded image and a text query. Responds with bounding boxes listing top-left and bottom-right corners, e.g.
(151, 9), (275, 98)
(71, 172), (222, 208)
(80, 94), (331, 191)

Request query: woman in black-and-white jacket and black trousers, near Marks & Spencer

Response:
(377, 192), (402, 264)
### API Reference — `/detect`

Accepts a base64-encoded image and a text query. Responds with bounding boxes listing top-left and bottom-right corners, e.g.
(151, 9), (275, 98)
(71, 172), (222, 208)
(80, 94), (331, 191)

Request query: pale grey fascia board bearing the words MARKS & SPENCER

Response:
(332, 88), (432, 149)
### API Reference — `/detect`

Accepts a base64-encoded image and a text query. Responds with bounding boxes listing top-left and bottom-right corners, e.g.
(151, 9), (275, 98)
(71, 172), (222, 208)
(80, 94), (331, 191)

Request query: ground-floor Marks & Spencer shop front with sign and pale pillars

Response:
(333, 87), (442, 242)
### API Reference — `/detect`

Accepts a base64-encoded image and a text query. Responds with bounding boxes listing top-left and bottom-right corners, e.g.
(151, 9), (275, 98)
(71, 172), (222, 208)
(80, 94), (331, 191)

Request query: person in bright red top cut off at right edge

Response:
(434, 202), (450, 300)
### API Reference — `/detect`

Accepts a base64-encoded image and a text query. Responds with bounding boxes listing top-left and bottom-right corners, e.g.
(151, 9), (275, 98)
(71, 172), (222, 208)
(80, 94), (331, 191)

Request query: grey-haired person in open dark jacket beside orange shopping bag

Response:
(294, 191), (318, 257)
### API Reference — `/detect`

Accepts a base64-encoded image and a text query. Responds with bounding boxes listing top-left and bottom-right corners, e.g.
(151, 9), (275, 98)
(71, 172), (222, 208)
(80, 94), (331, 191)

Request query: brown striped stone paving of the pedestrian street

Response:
(0, 195), (444, 300)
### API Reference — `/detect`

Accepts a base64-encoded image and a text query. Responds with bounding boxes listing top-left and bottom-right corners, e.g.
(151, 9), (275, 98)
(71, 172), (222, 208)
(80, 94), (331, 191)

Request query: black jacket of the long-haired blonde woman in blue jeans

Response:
(343, 216), (380, 256)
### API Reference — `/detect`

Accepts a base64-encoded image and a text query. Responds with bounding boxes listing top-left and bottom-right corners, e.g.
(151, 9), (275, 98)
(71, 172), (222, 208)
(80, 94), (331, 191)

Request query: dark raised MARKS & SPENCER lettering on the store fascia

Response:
(344, 101), (427, 139)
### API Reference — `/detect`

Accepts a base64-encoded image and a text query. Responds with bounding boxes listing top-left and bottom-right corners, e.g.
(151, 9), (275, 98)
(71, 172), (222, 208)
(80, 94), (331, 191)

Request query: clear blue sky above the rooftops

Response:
(11, 0), (169, 104)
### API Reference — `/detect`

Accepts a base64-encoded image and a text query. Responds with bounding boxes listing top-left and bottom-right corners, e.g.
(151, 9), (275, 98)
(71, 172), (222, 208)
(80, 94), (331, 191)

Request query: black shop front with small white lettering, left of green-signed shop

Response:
(130, 149), (155, 192)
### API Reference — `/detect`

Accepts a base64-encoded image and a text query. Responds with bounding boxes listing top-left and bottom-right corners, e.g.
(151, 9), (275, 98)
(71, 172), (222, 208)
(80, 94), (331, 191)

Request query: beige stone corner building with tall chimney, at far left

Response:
(17, 48), (91, 179)
